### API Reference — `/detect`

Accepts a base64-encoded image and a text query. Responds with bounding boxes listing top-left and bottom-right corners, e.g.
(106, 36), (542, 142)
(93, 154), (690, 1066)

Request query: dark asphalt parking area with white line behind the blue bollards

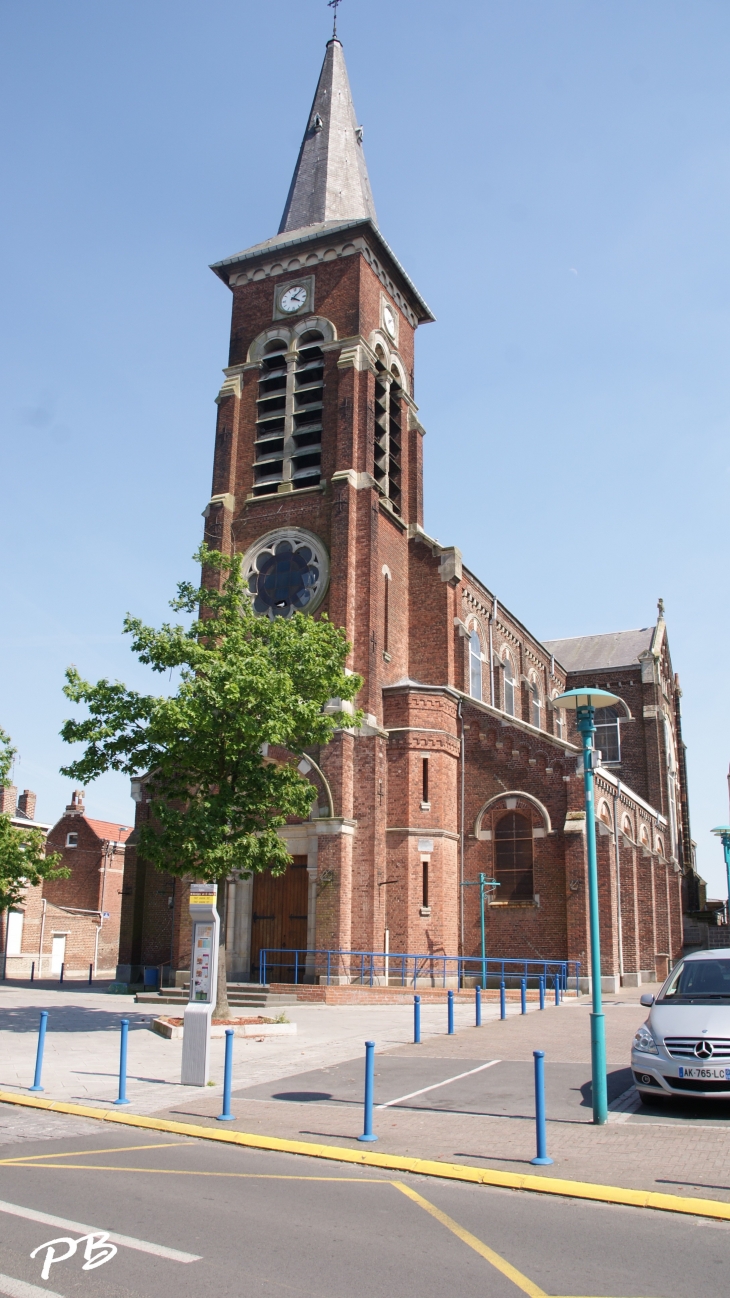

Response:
(236, 1054), (633, 1121)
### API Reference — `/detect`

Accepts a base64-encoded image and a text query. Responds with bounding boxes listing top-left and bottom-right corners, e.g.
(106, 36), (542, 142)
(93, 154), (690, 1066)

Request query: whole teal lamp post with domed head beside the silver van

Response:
(552, 689), (620, 1124)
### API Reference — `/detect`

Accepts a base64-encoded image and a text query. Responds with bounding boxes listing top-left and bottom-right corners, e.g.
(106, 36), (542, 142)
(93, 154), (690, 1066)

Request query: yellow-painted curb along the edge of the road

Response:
(0, 1090), (730, 1221)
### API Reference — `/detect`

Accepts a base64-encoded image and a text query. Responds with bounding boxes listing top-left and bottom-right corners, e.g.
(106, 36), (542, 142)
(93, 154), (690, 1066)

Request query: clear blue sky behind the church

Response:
(0, 0), (730, 896)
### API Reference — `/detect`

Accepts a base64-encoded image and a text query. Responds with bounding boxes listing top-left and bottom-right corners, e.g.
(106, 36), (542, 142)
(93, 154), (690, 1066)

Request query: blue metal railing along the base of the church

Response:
(258, 948), (581, 994)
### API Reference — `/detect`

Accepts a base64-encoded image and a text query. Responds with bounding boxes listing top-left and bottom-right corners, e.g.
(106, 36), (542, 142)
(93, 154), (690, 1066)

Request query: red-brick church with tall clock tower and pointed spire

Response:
(118, 39), (696, 990)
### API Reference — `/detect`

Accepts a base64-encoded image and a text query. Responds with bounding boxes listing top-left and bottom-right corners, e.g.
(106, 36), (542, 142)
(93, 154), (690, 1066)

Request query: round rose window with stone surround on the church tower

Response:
(244, 528), (330, 618)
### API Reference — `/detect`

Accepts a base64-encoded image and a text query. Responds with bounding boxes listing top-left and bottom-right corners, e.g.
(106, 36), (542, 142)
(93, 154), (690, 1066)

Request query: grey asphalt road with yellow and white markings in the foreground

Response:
(0, 1116), (730, 1298)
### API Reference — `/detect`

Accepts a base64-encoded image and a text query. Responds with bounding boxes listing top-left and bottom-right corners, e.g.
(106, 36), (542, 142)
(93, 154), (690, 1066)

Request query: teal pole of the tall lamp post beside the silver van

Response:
(576, 706), (608, 1125)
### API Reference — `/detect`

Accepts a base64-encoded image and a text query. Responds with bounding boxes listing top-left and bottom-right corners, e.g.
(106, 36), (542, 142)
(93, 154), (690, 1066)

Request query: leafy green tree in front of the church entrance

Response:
(61, 545), (362, 1016)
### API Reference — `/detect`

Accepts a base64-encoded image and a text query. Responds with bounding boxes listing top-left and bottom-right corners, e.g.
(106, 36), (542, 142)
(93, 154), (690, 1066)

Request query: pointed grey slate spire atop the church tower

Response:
(279, 38), (377, 234)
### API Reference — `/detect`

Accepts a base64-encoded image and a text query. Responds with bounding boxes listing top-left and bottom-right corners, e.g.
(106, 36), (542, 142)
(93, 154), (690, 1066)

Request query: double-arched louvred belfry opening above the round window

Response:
(253, 330), (325, 496)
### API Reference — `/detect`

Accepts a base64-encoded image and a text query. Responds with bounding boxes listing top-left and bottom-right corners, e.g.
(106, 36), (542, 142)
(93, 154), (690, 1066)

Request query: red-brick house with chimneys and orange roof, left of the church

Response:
(0, 789), (131, 979)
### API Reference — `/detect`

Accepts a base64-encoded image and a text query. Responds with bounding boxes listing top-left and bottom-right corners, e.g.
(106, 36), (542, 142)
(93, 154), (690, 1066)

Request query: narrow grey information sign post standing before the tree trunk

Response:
(181, 884), (221, 1086)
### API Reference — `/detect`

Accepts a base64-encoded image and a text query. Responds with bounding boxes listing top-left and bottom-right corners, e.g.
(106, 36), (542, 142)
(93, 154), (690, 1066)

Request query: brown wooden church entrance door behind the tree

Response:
(251, 857), (309, 983)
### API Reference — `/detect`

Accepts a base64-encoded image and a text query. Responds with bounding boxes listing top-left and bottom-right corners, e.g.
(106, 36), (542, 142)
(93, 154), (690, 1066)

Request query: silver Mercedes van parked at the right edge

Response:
(631, 948), (730, 1102)
